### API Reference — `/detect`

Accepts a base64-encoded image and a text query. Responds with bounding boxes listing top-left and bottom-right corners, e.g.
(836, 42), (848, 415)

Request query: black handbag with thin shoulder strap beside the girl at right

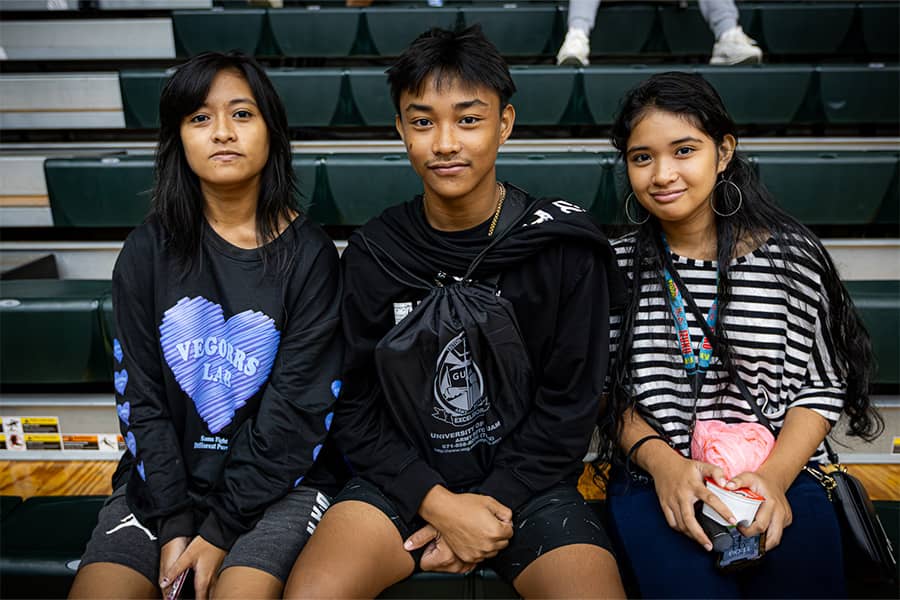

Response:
(670, 260), (898, 597)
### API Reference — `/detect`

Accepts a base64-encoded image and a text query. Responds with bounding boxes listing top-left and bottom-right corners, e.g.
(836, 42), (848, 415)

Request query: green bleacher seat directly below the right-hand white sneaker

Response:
(694, 65), (813, 125)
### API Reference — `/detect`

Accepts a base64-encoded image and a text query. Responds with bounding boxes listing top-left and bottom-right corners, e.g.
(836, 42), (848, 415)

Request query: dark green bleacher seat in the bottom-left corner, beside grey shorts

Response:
(0, 496), (106, 598)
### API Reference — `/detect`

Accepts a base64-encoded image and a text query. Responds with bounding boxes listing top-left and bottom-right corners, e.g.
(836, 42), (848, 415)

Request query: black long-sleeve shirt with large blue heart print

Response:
(113, 217), (341, 549)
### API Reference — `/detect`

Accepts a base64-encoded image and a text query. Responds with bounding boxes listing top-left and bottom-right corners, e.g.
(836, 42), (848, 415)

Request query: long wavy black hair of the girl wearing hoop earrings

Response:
(601, 72), (884, 460)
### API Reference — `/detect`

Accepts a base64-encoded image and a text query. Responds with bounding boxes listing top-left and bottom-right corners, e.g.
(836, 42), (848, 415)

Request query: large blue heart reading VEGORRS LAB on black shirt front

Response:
(159, 296), (281, 433)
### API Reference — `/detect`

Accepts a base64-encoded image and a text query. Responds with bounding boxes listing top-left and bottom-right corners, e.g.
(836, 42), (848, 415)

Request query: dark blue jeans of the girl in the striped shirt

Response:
(607, 471), (847, 598)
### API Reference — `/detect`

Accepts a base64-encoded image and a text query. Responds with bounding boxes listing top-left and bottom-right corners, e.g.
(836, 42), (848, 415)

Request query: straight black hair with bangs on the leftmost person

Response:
(152, 52), (300, 274)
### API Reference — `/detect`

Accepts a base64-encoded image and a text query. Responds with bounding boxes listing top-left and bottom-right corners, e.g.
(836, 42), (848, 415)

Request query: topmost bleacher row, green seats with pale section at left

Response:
(0, 0), (900, 60)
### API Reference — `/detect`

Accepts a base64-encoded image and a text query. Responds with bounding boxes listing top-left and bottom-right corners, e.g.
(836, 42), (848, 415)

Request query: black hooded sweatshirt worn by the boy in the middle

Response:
(333, 184), (623, 520)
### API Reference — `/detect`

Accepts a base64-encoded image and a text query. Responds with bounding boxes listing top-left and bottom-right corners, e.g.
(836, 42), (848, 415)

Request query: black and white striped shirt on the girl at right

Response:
(610, 235), (846, 461)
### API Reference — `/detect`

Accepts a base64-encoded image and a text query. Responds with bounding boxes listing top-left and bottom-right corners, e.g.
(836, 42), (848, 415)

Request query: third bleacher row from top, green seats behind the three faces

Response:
(44, 150), (900, 227)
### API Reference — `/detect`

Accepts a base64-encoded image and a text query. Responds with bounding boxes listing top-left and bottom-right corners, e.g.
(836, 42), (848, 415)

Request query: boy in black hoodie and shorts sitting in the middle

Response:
(286, 28), (624, 598)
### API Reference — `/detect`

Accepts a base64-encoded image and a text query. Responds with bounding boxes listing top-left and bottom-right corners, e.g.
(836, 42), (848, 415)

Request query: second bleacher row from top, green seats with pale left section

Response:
(0, 63), (900, 131)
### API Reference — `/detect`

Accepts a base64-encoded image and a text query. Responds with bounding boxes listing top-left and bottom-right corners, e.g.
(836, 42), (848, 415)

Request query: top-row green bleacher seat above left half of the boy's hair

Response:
(364, 3), (459, 56)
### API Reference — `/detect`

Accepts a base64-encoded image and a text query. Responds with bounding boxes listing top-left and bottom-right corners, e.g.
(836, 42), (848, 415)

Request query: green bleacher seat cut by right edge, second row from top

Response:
(818, 65), (900, 128)
